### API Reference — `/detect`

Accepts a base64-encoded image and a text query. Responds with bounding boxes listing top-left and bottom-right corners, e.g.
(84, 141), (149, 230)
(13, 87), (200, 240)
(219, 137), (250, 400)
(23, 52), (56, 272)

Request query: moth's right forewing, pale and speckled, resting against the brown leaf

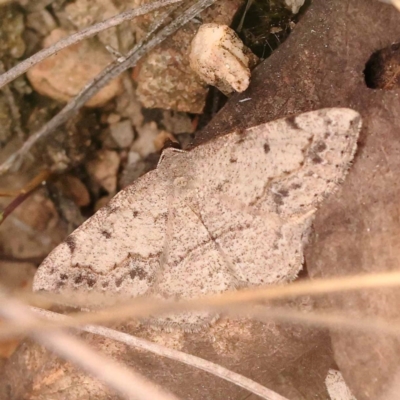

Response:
(189, 108), (361, 218)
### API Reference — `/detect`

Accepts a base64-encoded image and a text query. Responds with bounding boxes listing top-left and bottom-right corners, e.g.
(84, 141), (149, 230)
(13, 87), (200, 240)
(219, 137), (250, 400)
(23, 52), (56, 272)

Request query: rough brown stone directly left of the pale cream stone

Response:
(133, 0), (244, 114)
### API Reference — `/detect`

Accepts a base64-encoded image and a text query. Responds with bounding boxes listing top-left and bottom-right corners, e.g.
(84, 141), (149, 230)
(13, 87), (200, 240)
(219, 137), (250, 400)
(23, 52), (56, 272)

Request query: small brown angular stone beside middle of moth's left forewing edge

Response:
(86, 150), (120, 194)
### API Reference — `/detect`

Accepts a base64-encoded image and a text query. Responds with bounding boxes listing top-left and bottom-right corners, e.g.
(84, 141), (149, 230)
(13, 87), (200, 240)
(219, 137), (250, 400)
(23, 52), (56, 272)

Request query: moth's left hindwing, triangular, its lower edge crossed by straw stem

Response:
(147, 190), (238, 332)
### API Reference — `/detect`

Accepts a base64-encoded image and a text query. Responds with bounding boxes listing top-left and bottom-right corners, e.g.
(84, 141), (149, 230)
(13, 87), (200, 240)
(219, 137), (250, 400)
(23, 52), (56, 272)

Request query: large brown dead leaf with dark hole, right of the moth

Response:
(197, 0), (400, 400)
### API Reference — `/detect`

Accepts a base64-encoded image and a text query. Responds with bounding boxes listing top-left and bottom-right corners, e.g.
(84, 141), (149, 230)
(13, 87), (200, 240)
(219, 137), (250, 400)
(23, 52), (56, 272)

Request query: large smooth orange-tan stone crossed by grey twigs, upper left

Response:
(27, 29), (122, 107)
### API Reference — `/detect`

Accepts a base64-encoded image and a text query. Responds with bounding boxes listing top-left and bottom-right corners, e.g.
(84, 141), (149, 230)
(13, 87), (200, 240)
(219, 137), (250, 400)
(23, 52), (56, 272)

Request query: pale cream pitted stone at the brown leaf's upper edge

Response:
(189, 24), (257, 95)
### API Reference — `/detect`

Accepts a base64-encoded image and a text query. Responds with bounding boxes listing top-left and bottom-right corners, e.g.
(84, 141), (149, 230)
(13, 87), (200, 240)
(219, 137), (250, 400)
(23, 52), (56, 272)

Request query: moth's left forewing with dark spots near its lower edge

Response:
(33, 170), (169, 296)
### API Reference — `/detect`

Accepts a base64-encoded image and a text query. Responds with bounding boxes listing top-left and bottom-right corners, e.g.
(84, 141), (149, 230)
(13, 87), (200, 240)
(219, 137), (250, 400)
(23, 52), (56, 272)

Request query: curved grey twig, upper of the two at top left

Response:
(0, 0), (184, 88)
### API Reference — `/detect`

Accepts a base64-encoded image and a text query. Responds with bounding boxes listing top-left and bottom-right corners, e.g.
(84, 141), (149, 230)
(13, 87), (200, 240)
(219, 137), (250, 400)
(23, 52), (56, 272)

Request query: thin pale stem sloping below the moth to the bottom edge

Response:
(32, 307), (288, 400)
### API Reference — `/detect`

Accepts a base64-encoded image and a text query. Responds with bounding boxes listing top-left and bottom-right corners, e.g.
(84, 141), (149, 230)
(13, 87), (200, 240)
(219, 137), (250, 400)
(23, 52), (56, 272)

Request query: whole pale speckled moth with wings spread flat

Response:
(34, 108), (361, 331)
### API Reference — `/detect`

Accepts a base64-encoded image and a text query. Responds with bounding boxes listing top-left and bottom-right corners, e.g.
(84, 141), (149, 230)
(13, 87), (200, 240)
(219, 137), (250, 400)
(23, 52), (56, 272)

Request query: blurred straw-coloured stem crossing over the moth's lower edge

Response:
(0, 272), (400, 338)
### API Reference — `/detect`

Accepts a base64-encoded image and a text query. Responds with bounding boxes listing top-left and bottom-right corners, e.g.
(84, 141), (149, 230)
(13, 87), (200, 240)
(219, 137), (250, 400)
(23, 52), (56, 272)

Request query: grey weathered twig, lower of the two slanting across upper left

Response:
(0, 0), (216, 175)
